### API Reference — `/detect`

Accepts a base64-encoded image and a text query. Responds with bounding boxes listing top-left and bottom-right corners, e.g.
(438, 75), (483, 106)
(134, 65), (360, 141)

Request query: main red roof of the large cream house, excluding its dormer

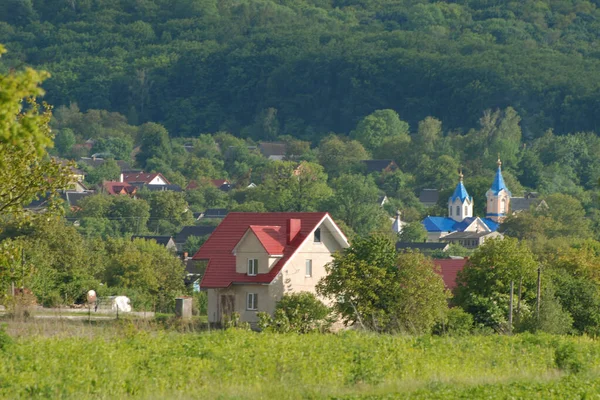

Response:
(193, 212), (328, 288)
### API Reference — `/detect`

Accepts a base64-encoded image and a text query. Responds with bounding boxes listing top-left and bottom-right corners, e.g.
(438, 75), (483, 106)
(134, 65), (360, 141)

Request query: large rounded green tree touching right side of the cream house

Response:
(317, 235), (447, 333)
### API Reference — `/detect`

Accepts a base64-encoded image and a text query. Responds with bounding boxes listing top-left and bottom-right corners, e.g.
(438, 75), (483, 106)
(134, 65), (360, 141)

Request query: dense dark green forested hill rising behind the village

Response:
(0, 0), (600, 139)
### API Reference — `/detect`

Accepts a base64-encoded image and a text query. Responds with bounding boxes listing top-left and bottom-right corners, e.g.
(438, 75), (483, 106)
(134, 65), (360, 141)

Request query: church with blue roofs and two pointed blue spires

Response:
(422, 159), (512, 248)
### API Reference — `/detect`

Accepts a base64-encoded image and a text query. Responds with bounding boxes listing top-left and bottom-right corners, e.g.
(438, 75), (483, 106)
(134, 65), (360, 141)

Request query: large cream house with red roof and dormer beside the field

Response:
(193, 212), (348, 324)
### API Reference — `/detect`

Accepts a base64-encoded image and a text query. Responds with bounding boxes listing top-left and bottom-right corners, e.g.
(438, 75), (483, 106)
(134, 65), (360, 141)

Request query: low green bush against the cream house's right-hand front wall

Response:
(259, 292), (332, 333)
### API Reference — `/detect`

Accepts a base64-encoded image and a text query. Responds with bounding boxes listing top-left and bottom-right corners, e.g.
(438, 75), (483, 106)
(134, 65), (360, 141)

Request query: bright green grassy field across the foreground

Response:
(0, 321), (600, 399)
